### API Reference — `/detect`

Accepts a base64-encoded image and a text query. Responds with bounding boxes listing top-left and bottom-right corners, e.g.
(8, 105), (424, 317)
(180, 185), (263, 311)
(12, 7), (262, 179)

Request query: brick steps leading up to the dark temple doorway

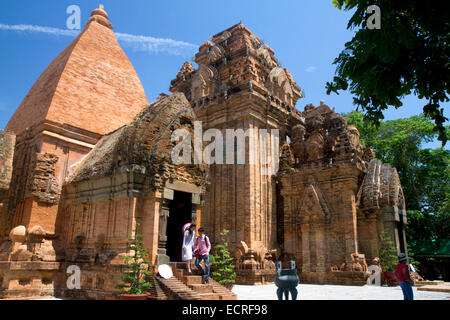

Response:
(170, 262), (237, 300)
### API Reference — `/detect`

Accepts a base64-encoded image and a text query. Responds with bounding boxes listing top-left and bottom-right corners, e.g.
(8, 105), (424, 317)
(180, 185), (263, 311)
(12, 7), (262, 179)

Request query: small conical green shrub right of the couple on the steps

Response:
(211, 230), (236, 290)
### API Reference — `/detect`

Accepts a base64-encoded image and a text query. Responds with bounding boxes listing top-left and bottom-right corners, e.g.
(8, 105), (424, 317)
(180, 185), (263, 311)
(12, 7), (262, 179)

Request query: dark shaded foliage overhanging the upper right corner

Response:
(326, 0), (450, 145)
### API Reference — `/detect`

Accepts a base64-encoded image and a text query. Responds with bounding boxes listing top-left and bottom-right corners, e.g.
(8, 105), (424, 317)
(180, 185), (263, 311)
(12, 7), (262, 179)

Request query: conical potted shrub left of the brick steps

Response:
(116, 223), (152, 300)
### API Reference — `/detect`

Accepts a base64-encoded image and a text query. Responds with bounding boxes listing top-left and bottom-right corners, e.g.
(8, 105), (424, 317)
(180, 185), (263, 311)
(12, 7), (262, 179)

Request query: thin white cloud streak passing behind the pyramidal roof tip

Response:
(0, 24), (198, 56)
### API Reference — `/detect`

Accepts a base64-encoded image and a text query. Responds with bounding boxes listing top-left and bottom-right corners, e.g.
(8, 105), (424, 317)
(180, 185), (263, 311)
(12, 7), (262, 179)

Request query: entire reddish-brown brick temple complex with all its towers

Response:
(0, 8), (406, 299)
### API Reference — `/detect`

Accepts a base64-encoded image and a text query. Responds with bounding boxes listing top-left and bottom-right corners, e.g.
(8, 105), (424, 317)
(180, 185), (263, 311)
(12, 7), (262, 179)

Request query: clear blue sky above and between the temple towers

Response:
(0, 0), (446, 148)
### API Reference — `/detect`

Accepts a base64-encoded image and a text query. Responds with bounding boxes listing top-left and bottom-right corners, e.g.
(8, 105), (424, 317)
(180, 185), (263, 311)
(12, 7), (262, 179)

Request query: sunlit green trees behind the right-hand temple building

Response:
(344, 111), (450, 241)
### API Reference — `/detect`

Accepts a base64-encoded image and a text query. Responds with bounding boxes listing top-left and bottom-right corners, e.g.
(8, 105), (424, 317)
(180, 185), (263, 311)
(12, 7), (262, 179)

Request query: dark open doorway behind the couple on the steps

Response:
(166, 191), (192, 262)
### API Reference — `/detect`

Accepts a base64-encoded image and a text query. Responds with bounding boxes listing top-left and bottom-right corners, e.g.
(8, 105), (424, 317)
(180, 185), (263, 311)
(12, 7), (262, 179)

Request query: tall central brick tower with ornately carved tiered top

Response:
(171, 23), (302, 283)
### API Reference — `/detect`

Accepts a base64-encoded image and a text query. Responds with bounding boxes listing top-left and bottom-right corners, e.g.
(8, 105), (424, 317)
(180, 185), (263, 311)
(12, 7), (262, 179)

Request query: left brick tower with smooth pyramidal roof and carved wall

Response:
(0, 8), (148, 250)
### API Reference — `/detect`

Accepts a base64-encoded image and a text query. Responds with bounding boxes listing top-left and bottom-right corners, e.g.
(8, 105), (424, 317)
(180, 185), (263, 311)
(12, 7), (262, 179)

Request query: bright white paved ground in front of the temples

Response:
(233, 284), (450, 300)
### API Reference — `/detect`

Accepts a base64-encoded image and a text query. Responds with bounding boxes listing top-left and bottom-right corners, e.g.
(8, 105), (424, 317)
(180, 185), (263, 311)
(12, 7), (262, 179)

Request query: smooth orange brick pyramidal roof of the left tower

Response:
(5, 8), (148, 135)
